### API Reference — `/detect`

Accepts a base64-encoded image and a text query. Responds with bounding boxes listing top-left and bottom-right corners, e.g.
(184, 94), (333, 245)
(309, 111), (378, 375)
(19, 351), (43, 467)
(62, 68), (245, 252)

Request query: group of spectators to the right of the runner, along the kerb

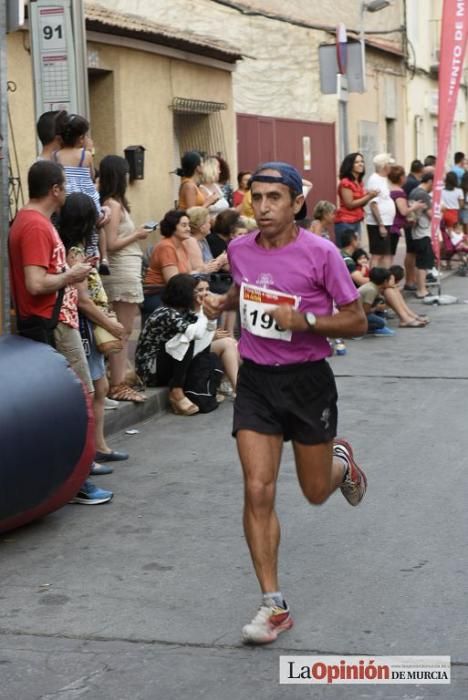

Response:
(304, 152), (468, 352)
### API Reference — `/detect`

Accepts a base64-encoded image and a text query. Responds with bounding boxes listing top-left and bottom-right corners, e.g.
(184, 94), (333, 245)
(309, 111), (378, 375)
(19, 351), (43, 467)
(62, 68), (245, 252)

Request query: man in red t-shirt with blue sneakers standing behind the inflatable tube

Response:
(9, 161), (113, 505)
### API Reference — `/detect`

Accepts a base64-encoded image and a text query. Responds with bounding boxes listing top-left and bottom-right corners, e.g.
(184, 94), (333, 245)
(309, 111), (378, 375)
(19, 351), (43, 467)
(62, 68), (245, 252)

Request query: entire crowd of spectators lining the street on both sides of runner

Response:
(10, 105), (468, 503)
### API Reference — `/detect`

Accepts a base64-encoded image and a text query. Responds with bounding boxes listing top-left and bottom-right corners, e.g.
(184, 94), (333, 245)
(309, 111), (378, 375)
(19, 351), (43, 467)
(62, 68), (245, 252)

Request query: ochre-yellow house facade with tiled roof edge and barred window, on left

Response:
(7, 6), (240, 225)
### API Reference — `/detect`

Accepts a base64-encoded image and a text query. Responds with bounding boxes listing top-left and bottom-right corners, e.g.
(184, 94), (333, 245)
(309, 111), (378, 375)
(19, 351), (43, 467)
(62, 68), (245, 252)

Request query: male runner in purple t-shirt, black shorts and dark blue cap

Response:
(205, 162), (367, 644)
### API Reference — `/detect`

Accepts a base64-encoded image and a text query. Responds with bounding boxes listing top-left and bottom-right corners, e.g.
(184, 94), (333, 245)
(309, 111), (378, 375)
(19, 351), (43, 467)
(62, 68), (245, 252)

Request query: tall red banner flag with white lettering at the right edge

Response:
(431, 0), (468, 260)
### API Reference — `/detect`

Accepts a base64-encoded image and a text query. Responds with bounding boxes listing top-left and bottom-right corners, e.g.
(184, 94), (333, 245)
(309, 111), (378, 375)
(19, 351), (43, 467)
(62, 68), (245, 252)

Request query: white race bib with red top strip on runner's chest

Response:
(240, 283), (301, 342)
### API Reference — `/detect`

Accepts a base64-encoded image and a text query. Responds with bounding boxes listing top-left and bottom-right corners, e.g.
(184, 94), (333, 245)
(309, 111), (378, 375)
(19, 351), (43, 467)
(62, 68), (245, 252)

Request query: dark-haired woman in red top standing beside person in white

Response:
(335, 153), (378, 248)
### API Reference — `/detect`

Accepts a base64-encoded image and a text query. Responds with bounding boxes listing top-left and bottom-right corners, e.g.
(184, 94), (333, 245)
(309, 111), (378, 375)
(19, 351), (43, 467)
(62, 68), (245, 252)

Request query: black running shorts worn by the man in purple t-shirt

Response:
(232, 360), (338, 445)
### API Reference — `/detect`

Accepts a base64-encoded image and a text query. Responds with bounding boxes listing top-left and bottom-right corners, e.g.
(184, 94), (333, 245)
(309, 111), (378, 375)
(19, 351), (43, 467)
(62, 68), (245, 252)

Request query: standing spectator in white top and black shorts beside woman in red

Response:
(366, 153), (396, 267)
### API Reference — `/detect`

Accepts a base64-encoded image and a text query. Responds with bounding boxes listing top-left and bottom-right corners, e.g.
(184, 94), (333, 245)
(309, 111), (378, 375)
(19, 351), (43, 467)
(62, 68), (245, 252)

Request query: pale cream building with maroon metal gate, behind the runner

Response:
(94, 0), (406, 191)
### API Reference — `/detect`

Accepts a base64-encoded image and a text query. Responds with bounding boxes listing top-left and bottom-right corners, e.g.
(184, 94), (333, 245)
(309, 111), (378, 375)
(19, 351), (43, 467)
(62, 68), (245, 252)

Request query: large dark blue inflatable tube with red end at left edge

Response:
(0, 336), (95, 532)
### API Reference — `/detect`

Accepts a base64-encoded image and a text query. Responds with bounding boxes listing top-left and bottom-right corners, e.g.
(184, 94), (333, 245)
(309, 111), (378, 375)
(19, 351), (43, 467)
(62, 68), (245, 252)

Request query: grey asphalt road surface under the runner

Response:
(0, 277), (468, 700)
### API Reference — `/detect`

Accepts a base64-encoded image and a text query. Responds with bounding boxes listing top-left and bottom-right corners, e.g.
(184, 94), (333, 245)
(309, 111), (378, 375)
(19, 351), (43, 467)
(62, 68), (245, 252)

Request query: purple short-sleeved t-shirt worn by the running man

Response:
(228, 228), (359, 365)
